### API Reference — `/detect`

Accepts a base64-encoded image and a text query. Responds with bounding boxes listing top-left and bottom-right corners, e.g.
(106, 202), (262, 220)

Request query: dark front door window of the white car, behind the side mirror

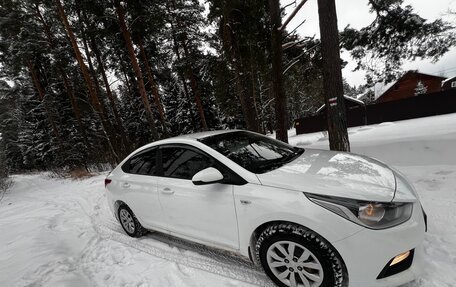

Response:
(161, 147), (214, 180)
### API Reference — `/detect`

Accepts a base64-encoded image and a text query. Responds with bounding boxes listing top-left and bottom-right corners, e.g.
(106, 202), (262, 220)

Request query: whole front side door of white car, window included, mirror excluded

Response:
(157, 146), (239, 249)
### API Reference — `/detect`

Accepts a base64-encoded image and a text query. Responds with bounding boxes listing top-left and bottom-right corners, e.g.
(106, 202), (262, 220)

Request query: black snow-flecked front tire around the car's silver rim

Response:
(255, 223), (348, 287)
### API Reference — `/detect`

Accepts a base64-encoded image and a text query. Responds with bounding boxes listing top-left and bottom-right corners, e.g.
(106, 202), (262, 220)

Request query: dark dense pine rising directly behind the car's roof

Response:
(209, 0), (273, 132)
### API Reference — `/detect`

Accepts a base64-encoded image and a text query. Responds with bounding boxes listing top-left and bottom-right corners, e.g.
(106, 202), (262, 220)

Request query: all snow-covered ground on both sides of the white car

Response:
(0, 114), (456, 287)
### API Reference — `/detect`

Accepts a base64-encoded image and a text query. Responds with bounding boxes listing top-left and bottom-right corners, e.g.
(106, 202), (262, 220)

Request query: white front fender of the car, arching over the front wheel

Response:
(234, 184), (363, 256)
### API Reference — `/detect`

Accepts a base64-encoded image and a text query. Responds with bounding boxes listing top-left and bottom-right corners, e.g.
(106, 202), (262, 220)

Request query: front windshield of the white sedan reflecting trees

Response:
(199, 131), (304, 173)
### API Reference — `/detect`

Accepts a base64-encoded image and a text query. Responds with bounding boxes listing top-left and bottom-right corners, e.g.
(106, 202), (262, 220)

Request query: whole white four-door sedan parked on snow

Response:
(105, 130), (426, 287)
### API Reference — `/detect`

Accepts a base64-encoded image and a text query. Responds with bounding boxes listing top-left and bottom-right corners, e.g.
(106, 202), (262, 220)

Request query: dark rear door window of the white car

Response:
(122, 149), (157, 175)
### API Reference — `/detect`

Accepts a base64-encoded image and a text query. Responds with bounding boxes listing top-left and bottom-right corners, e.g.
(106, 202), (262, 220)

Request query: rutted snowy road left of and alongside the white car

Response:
(0, 174), (272, 286)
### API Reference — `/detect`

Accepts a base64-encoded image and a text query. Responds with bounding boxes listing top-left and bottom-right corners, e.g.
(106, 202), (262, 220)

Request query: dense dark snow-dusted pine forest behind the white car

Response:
(0, 0), (456, 172)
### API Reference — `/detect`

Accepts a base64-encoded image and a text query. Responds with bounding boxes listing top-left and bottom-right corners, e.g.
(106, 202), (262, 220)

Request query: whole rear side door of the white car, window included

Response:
(121, 149), (167, 229)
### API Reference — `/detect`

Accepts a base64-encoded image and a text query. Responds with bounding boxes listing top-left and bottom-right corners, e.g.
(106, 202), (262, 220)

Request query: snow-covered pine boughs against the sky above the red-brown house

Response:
(341, 0), (456, 87)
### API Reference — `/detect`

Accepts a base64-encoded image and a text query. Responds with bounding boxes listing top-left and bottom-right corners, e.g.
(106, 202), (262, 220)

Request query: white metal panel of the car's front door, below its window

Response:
(158, 177), (239, 250)
